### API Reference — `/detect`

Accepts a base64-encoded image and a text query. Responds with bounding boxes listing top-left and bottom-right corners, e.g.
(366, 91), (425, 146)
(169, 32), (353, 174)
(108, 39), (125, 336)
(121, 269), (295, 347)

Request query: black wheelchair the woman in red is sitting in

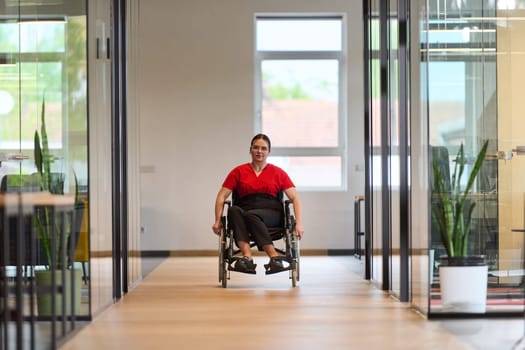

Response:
(219, 191), (300, 288)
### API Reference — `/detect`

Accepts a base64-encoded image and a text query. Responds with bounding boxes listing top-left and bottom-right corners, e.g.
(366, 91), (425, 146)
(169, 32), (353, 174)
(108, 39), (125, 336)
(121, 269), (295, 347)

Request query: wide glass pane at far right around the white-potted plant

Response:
(420, 0), (525, 314)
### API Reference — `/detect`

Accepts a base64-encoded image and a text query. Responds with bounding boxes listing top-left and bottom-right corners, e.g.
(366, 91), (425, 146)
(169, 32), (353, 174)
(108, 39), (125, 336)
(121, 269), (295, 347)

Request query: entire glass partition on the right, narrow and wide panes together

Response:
(366, 0), (525, 316)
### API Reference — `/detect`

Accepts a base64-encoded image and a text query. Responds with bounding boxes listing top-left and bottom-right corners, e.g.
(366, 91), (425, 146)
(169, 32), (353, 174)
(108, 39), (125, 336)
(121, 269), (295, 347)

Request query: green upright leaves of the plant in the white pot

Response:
(431, 141), (488, 257)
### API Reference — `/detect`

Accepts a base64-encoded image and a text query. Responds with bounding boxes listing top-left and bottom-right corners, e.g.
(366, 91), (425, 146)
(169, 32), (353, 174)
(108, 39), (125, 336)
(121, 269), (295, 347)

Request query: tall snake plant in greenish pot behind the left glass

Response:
(33, 100), (83, 316)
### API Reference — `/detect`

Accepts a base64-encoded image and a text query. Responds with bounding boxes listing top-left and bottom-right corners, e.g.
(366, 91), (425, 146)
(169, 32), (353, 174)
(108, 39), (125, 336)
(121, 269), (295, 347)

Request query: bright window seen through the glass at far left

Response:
(0, 21), (66, 173)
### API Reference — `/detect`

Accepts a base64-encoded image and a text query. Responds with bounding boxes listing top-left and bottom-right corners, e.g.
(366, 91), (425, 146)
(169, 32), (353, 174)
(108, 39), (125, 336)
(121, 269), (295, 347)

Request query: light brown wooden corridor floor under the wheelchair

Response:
(61, 256), (522, 350)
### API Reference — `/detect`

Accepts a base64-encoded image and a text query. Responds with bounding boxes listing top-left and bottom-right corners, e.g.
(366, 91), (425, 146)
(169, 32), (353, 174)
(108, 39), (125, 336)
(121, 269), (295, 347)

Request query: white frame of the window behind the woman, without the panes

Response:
(254, 14), (348, 191)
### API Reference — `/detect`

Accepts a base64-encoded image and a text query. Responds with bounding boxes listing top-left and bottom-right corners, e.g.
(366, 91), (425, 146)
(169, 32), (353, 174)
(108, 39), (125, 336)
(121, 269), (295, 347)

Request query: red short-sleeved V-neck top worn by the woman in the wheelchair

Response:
(222, 163), (295, 198)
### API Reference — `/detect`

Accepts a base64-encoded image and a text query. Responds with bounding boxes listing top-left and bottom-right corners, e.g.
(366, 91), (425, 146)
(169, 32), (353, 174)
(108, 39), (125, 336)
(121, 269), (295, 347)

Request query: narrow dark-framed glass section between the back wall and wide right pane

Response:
(365, 0), (408, 299)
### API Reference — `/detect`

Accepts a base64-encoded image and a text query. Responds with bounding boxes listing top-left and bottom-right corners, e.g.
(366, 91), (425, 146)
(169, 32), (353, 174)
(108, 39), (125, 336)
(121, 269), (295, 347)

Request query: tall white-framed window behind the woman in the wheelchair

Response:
(255, 16), (346, 190)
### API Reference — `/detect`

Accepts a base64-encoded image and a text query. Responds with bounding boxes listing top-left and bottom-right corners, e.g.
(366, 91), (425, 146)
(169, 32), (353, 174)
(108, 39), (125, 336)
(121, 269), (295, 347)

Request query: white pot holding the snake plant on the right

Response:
(439, 265), (488, 313)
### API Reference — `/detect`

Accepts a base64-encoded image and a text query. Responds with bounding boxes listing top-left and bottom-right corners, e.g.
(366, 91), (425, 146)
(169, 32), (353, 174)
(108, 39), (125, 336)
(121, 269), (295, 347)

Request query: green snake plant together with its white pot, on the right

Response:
(431, 141), (488, 313)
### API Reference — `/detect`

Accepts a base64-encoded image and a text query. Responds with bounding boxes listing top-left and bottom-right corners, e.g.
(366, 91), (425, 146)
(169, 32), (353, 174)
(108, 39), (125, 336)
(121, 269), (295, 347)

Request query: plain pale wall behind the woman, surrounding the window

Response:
(137, 0), (364, 250)
